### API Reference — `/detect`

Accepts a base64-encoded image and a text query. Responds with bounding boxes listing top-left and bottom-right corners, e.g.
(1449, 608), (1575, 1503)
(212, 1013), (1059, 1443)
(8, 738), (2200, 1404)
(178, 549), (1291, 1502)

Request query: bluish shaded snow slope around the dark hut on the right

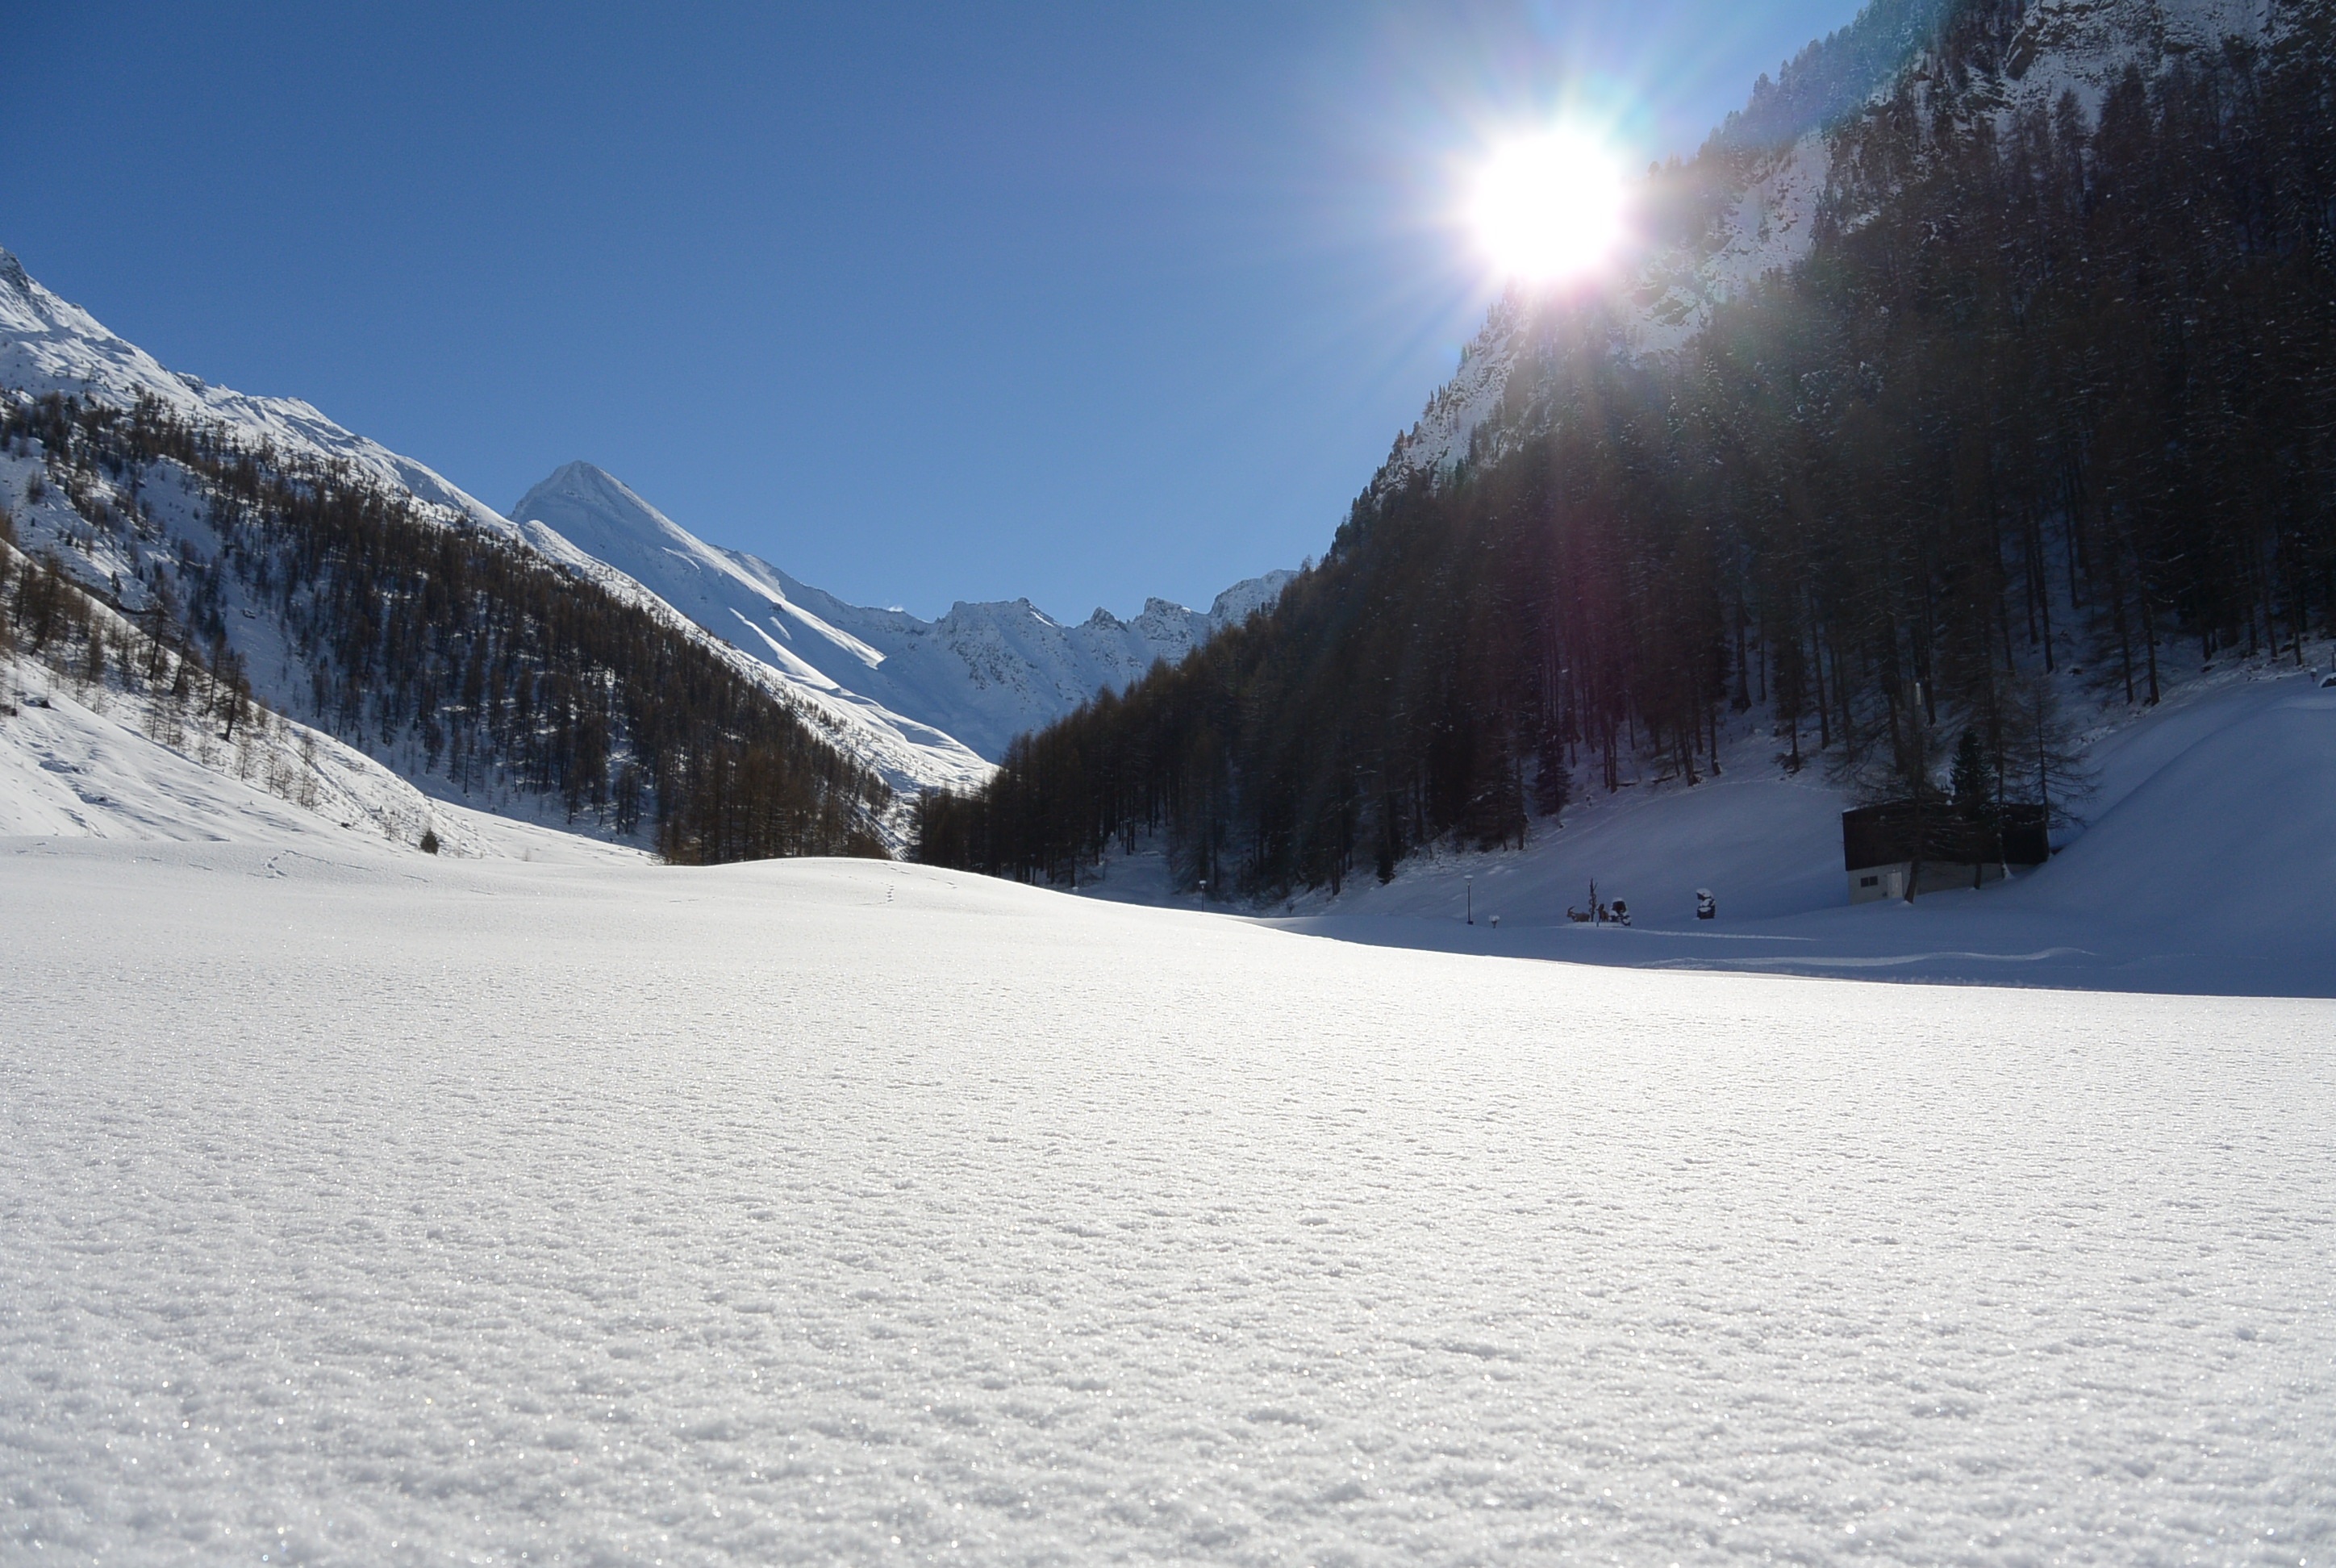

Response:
(1252, 669), (2336, 995)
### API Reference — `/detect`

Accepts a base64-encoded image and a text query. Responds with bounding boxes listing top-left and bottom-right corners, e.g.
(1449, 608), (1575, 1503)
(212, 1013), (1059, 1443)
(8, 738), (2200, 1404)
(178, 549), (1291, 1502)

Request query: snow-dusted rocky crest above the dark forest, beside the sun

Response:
(1371, 0), (2284, 493)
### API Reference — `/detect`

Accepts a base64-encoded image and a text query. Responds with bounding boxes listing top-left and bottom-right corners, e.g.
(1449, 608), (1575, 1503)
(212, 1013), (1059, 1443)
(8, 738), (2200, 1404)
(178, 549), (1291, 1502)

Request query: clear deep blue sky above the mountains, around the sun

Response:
(0, 0), (1857, 617)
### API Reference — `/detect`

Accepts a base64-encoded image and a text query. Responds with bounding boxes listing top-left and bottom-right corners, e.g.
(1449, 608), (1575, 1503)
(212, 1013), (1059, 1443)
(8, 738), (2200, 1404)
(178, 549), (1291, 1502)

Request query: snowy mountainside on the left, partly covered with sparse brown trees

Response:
(0, 252), (904, 860)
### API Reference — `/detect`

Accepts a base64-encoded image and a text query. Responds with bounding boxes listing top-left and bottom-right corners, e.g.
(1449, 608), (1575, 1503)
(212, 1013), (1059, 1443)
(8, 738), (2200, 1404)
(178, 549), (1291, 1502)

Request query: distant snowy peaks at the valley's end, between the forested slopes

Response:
(511, 463), (1294, 761)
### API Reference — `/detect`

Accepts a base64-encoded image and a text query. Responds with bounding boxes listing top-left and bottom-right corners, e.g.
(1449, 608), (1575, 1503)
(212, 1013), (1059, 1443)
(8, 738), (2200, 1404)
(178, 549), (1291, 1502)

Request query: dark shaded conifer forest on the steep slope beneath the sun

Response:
(920, 0), (2336, 893)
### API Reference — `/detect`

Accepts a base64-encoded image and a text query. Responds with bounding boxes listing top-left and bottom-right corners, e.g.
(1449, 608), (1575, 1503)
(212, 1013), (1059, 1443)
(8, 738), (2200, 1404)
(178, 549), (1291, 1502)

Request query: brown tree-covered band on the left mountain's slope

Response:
(0, 395), (890, 860)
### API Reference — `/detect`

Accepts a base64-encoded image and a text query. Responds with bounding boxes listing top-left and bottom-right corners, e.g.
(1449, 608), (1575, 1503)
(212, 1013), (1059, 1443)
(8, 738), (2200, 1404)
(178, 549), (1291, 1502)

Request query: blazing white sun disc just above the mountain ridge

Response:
(1470, 126), (1629, 285)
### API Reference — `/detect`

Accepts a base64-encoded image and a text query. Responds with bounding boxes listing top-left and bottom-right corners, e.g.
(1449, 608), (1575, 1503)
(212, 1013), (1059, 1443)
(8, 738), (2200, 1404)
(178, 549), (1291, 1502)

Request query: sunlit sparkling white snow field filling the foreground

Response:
(0, 839), (2336, 1563)
